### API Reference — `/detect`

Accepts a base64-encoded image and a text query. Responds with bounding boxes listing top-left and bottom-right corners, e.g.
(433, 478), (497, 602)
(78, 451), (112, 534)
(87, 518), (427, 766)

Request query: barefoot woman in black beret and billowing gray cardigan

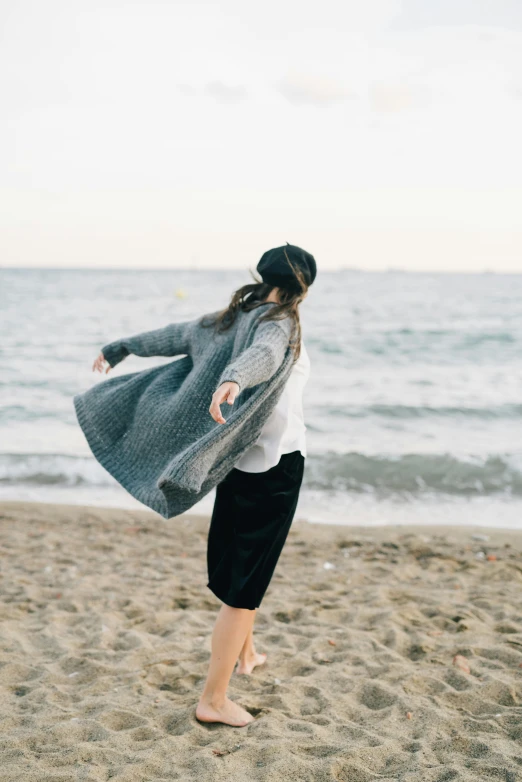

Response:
(74, 244), (317, 727)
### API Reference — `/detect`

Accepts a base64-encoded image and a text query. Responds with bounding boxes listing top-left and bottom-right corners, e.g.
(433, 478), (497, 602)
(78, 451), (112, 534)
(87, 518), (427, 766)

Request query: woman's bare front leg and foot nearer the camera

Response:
(196, 604), (255, 727)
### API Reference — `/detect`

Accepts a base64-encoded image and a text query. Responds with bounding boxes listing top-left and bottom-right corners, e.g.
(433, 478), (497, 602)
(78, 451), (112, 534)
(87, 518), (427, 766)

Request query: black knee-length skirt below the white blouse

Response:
(207, 451), (305, 610)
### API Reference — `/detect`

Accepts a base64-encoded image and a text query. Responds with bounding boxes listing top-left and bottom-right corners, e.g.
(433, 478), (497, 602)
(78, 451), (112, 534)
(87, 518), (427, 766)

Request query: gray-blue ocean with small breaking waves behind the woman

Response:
(0, 268), (522, 528)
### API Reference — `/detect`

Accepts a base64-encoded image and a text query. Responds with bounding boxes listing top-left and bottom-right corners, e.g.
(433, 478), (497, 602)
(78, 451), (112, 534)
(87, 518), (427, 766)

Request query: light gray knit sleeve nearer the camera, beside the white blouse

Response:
(216, 318), (291, 391)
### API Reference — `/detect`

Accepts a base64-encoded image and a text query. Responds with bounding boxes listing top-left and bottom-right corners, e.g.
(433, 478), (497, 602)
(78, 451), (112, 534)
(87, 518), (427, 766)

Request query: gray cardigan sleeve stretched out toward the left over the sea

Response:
(101, 321), (194, 367)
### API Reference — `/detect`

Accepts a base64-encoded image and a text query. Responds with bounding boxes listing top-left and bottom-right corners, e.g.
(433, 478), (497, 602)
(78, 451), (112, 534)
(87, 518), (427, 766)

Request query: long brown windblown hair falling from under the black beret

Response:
(201, 250), (308, 362)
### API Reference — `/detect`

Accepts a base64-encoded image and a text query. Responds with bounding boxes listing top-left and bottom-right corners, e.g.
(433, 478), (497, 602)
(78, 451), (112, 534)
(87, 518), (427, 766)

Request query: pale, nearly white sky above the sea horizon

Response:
(0, 0), (522, 271)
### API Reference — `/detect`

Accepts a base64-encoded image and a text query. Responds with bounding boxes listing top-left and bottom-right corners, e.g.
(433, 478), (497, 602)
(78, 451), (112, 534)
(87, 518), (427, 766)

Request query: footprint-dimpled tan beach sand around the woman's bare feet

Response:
(0, 502), (522, 782)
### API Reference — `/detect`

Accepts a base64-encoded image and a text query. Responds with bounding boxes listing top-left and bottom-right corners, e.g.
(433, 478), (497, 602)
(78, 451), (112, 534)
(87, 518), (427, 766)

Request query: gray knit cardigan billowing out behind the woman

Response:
(73, 302), (293, 519)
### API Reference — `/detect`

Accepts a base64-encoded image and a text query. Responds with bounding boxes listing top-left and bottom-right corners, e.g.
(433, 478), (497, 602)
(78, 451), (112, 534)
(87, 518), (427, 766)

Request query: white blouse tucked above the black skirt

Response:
(234, 341), (310, 472)
